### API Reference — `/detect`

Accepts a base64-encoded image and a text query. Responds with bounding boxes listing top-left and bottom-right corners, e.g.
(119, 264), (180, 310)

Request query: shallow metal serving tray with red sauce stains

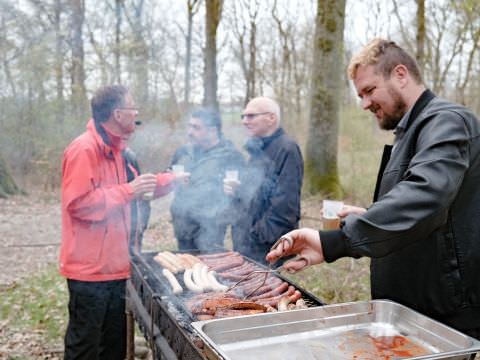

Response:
(192, 300), (480, 360)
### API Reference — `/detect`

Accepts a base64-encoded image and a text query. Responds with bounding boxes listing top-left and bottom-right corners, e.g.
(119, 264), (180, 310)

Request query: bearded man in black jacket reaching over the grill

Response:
(267, 39), (480, 339)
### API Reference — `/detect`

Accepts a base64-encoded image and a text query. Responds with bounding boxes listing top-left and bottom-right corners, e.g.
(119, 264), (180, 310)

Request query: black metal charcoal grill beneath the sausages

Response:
(127, 250), (323, 360)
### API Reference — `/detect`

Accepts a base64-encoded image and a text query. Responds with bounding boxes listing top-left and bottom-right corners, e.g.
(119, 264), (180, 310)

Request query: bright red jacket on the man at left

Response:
(60, 120), (174, 281)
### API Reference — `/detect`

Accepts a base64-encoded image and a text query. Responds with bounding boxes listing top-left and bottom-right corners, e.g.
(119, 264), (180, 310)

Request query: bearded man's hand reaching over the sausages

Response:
(266, 228), (325, 272)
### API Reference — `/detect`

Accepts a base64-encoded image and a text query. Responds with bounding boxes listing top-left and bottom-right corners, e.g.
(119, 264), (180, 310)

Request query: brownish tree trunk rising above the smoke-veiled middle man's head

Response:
(203, 0), (223, 110)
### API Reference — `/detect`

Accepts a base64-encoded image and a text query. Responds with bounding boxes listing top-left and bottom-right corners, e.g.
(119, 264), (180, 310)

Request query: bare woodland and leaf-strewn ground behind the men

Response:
(0, 0), (480, 358)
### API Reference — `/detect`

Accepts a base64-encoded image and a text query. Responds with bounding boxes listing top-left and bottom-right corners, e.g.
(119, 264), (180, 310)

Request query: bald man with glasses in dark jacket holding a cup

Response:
(224, 97), (303, 263)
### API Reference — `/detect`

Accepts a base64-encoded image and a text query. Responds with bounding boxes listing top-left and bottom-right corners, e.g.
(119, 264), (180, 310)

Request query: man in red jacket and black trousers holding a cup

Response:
(60, 85), (174, 359)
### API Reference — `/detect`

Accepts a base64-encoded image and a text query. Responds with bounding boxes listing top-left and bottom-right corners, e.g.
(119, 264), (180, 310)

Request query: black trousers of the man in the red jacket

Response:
(65, 279), (127, 360)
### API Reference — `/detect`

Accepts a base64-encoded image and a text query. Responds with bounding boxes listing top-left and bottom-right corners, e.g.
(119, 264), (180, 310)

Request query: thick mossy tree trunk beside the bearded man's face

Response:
(305, 0), (345, 197)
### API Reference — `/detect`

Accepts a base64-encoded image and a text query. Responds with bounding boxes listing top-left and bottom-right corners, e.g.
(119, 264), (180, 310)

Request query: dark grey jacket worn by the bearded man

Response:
(320, 90), (480, 330)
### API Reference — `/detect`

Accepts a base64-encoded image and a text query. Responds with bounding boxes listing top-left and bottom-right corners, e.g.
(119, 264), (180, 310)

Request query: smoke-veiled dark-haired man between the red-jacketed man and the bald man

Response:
(170, 109), (244, 251)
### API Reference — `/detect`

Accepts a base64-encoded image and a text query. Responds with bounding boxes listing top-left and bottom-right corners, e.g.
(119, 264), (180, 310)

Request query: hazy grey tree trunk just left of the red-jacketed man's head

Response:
(71, 0), (87, 121)
